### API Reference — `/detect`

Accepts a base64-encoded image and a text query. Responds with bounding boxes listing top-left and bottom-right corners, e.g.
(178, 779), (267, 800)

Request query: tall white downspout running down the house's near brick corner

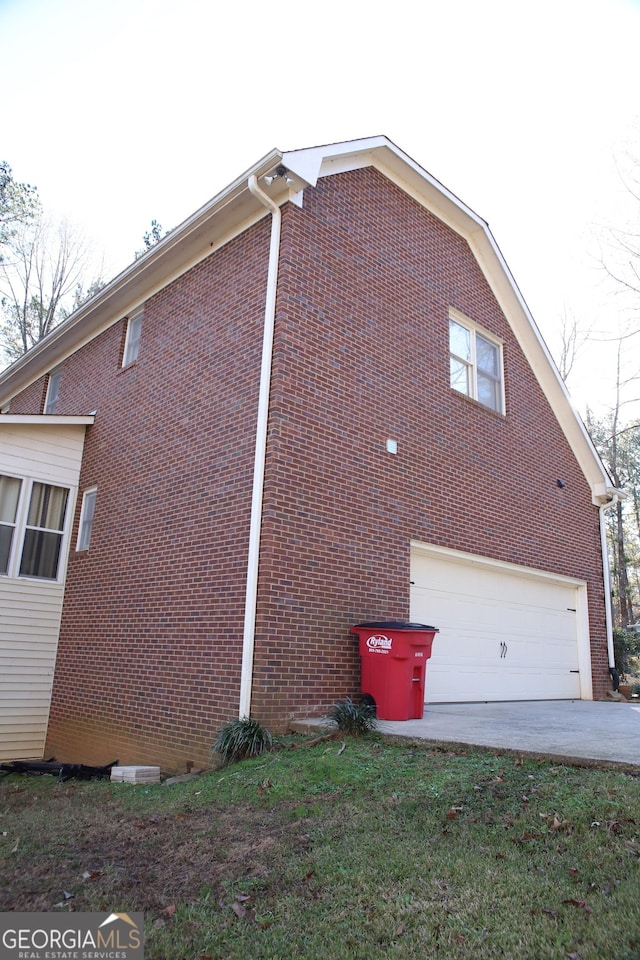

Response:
(239, 174), (282, 719)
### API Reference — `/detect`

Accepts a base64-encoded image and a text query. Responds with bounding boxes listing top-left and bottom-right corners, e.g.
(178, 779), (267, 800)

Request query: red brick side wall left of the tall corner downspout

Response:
(12, 217), (270, 770)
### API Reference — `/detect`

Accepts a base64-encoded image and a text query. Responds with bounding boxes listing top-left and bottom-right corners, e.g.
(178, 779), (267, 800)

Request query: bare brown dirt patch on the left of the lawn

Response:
(0, 777), (307, 916)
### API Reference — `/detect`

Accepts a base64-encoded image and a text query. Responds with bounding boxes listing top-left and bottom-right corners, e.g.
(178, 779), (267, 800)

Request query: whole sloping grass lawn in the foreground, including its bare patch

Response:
(0, 736), (640, 960)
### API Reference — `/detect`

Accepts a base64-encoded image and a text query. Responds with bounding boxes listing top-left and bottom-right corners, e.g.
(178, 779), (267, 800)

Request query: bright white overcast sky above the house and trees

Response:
(0, 0), (640, 418)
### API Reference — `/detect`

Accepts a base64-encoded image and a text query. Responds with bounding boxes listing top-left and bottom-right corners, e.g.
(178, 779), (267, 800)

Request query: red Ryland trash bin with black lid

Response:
(351, 620), (438, 720)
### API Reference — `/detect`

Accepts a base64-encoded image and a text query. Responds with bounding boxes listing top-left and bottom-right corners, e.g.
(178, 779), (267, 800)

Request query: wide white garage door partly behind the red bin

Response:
(411, 545), (591, 703)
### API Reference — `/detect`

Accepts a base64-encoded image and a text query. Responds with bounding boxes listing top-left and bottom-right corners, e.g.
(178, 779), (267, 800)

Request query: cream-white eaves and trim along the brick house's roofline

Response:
(0, 136), (612, 503)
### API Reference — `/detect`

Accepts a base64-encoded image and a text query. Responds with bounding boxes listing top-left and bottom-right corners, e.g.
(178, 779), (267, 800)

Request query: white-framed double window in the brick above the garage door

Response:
(449, 311), (504, 413)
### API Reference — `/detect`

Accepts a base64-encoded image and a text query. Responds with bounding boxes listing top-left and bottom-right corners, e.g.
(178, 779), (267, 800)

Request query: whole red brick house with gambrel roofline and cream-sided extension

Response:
(0, 137), (615, 769)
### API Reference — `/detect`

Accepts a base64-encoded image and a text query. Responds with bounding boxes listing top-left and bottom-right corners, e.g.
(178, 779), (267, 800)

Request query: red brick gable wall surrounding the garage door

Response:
(248, 170), (608, 726)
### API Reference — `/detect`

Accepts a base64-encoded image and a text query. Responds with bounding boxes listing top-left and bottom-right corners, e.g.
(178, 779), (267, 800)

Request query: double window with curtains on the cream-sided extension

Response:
(0, 475), (69, 580)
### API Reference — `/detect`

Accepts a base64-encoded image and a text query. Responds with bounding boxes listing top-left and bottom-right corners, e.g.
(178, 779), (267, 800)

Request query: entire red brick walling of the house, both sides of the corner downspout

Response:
(11, 163), (607, 769)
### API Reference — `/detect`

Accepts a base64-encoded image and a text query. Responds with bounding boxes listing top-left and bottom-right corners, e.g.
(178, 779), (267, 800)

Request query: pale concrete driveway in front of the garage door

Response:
(378, 700), (640, 767)
